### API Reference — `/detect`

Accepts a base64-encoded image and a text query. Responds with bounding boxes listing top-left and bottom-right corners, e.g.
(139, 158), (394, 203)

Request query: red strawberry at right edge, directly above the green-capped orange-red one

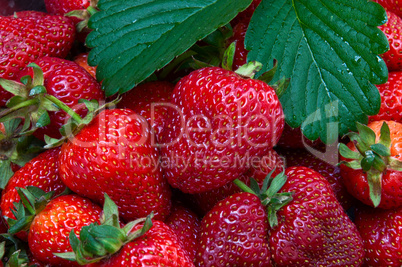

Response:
(369, 71), (402, 122)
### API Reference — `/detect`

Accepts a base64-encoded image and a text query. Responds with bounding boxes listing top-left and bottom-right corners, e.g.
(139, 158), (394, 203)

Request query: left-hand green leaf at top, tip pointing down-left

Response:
(86, 0), (251, 96)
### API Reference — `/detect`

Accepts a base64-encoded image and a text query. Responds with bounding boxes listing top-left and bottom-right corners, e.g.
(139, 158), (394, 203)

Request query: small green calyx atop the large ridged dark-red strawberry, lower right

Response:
(233, 170), (293, 227)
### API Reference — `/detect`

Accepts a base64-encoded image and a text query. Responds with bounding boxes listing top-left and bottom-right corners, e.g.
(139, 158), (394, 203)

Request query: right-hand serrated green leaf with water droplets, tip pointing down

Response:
(245, 0), (388, 143)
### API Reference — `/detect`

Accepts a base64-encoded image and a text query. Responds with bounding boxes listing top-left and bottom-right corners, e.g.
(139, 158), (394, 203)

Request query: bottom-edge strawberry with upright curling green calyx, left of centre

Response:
(58, 195), (194, 267)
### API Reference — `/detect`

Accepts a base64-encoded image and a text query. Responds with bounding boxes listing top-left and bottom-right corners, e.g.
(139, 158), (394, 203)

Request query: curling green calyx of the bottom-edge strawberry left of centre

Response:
(54, 194), (153, 265)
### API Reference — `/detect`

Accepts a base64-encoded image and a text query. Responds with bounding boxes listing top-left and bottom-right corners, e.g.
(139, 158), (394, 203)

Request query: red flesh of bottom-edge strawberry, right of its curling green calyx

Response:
(88, 220), (194, 267)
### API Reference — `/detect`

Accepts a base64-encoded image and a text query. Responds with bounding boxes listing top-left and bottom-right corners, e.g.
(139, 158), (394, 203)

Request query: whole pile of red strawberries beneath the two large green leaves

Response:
(0, 0), (402, 267)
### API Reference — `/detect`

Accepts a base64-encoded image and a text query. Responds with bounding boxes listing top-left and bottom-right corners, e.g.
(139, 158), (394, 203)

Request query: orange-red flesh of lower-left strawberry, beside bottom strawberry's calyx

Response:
(28, 195), (102, 266)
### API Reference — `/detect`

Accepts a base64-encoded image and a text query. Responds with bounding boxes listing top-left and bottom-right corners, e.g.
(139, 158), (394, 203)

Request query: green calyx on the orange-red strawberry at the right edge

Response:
(339, 122), (402, 207)
